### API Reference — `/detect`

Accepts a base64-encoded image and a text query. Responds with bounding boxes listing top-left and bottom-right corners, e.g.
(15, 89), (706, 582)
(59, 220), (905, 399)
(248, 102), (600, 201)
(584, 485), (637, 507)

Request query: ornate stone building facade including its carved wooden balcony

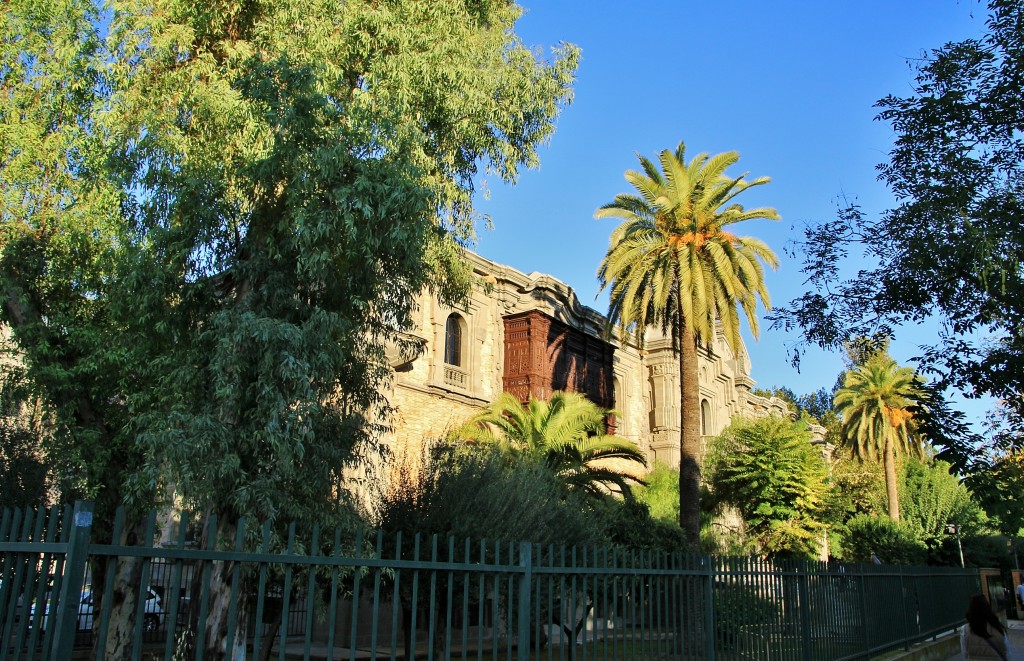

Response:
(380, 253), (786, 466)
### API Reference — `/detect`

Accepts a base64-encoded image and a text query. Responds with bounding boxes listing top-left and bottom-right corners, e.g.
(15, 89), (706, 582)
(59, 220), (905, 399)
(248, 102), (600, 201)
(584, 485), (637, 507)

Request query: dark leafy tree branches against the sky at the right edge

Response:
(774, 0), (1024, 413)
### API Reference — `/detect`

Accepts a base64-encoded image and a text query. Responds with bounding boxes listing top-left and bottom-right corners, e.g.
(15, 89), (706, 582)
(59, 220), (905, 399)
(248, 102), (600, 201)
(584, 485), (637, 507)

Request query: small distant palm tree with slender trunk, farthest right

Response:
(834, 352), (923, 521)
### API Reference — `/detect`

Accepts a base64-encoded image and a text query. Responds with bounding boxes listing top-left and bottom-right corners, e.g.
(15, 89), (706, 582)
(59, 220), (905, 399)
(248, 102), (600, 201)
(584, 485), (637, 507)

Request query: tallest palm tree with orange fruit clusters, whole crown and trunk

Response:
(595, 142), (779, 545)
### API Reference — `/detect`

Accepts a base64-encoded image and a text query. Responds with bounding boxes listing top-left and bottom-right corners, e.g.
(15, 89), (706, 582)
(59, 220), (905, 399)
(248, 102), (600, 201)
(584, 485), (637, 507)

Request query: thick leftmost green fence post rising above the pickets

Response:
(44, 500), (93, 659)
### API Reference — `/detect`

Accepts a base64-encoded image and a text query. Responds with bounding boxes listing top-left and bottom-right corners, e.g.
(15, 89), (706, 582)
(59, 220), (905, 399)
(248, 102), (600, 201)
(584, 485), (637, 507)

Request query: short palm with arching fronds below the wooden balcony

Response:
(456, 391), (647, 496)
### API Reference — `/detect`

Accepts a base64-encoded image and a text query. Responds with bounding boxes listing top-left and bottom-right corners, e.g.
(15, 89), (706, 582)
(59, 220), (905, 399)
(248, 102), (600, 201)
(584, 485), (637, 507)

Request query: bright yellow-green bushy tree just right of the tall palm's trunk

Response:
(708, 417), (827, 556)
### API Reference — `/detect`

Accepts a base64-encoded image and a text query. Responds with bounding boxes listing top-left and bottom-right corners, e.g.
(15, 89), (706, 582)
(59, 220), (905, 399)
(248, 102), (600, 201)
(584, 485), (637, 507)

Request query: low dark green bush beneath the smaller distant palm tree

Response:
(835, 515), (928, 565)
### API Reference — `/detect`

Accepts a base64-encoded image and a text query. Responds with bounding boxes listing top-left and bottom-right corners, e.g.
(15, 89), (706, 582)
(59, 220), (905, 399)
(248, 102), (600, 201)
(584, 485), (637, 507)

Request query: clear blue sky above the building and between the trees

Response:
(468, 0), (987, 425)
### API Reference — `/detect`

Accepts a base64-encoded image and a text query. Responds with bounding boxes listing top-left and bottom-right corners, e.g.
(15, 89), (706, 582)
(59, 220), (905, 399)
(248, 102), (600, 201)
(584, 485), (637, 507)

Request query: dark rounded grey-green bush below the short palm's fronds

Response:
(373, 443), (604, 544)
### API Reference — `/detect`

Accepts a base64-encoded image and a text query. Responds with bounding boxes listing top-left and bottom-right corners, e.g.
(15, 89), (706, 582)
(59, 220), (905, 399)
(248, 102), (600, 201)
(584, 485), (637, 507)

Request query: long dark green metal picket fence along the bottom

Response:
(0, 503), (980, 661)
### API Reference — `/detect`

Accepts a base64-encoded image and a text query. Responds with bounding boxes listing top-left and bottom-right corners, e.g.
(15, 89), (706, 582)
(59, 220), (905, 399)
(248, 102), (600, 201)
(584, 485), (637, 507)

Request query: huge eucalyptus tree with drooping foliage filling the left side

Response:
(0, 0), (578, 659)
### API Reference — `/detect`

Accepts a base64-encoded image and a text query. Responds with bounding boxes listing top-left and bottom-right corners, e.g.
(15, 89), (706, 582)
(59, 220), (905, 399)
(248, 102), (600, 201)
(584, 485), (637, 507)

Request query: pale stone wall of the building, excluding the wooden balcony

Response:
(389, 253), (786, 466)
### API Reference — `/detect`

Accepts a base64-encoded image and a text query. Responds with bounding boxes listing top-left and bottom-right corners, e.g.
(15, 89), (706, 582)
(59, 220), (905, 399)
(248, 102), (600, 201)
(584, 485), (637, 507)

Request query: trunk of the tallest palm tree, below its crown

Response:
(679, 328), (700, 549)
